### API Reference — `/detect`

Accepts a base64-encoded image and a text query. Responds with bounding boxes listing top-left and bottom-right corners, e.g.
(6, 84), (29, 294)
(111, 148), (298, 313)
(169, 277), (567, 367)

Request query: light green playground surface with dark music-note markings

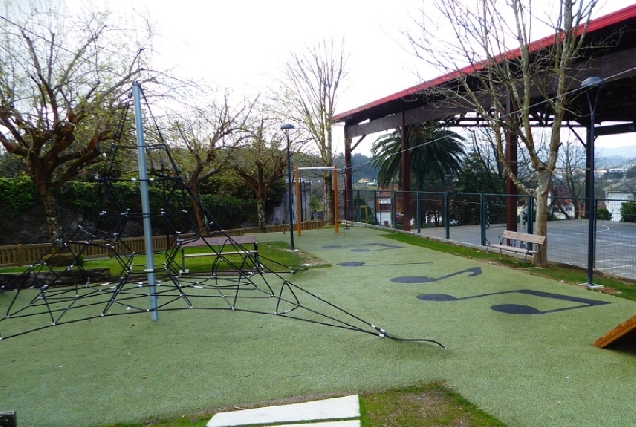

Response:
(0, 227), (636, 427)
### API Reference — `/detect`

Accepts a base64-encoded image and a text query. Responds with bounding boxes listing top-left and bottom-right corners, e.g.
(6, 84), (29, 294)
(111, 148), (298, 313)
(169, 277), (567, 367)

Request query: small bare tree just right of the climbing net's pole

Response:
(171, 91), (254, 231)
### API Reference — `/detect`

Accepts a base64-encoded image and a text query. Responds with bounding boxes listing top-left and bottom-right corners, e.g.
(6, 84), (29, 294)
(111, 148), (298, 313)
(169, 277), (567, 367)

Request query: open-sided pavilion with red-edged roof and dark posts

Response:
(333, 5), (636, 230)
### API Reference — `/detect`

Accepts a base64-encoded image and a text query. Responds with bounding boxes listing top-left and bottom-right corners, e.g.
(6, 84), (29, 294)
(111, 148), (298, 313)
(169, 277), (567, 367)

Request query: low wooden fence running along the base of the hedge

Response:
(0, 221), (327, 267)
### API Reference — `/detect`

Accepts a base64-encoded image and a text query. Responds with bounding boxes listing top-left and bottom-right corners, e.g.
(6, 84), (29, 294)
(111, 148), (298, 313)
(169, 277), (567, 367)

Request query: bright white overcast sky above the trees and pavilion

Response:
(66, 0), (630, 154)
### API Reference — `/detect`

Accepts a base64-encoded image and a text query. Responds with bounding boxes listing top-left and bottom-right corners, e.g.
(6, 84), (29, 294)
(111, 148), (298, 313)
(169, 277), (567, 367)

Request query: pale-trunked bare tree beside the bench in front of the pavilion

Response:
(410, 0), (596, 264)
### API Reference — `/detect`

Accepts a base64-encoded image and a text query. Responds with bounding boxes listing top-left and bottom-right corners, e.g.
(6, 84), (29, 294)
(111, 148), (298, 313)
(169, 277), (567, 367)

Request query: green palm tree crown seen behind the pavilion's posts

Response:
(371, 125), (464, 191)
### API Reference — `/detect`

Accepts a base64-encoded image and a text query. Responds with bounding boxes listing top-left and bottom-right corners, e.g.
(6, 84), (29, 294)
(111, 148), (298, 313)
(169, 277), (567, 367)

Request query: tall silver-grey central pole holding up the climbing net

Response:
(133, 82), (159, 320)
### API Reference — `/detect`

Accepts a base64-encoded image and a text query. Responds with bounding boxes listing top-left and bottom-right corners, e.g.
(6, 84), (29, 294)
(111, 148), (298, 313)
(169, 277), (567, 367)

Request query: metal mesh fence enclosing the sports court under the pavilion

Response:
(340, 190), (636, 279)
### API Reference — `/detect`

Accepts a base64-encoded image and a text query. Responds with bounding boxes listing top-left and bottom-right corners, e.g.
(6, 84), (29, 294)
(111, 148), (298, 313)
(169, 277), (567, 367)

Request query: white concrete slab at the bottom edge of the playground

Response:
(207, 395), (360, 427)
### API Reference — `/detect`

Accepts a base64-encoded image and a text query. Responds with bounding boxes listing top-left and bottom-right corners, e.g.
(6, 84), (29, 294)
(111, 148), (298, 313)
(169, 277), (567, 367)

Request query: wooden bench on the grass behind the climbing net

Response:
(181, 236), (261, 274)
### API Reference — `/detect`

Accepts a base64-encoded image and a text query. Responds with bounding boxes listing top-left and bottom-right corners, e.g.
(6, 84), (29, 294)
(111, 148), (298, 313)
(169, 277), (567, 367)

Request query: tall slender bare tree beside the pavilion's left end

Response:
(279, 40), (347, 226)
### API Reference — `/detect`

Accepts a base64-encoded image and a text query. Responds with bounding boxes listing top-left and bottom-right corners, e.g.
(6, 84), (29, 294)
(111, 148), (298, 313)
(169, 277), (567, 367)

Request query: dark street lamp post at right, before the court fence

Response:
(581, 77), (605, 289)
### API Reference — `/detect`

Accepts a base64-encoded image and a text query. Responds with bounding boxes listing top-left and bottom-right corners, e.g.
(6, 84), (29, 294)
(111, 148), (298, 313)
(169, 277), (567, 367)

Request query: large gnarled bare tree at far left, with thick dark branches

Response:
(0, 0), (157, 242)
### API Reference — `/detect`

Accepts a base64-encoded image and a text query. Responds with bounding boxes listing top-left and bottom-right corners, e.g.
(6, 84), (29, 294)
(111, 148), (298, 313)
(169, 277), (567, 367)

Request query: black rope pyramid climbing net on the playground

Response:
(0, 83), (441, 346)
